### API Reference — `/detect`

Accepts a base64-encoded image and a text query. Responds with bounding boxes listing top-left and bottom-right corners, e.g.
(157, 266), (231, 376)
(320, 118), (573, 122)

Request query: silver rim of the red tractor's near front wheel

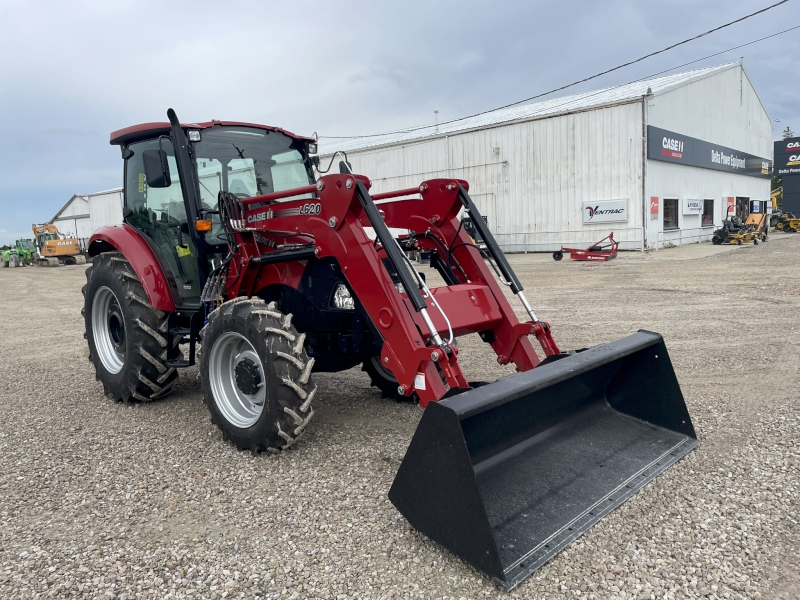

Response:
(208, 331), (267, 429)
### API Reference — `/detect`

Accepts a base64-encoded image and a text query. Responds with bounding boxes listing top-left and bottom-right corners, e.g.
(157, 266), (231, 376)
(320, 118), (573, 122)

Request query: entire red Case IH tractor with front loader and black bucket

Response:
(83, 109), (698, 588)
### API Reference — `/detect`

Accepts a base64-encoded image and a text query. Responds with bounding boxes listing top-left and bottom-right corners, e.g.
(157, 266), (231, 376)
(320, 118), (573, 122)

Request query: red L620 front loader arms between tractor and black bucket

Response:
(219, 175), (558, 406)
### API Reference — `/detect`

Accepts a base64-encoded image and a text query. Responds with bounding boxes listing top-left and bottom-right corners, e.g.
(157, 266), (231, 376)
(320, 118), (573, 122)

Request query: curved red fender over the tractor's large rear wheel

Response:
(89, 224), (175, 312)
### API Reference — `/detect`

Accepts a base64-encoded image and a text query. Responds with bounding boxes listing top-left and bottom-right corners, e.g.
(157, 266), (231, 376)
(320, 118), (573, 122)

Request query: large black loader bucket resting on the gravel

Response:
(389, 331), (699, 589)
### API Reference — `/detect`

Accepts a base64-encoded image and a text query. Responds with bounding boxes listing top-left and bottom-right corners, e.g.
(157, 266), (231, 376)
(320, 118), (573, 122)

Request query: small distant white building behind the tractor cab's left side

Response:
(50, 188), (122, 240)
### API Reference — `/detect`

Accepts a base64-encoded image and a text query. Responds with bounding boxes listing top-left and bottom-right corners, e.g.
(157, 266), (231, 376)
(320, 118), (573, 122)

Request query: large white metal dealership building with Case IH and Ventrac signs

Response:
(321, 62), (772, 252)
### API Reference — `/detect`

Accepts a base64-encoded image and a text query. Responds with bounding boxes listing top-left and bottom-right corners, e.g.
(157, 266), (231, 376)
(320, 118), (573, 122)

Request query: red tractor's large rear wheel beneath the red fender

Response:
(81, 252), (178, 404)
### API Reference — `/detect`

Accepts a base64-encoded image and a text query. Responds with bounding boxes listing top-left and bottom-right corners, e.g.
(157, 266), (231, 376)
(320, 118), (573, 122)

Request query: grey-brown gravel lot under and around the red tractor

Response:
(0, 233), (800, 600)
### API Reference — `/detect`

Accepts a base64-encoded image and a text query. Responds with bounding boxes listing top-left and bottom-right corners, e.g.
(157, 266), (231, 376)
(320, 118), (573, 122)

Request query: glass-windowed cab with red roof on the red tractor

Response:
(111, 113), (316, 308)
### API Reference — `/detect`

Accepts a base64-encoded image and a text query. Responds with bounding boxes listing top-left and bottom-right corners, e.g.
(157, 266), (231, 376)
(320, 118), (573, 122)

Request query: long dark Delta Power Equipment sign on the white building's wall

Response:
(647, 125), (772, 179)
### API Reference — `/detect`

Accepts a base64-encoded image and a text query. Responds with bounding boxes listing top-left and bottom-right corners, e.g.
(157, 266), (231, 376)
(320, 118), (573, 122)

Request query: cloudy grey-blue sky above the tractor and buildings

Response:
(0, 0), (800, 244)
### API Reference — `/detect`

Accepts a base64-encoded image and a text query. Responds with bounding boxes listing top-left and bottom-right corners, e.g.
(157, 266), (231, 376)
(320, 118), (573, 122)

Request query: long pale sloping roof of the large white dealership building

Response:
(320, 62), (740, 155)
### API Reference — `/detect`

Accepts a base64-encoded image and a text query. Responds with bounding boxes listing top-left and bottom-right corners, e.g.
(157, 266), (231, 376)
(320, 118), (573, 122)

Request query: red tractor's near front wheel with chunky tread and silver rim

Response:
(200, 297), (317, 452)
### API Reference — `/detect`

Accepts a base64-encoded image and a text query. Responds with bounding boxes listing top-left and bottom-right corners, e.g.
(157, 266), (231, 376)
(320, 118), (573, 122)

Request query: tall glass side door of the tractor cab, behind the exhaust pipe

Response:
(125, 136), (202, 308)
